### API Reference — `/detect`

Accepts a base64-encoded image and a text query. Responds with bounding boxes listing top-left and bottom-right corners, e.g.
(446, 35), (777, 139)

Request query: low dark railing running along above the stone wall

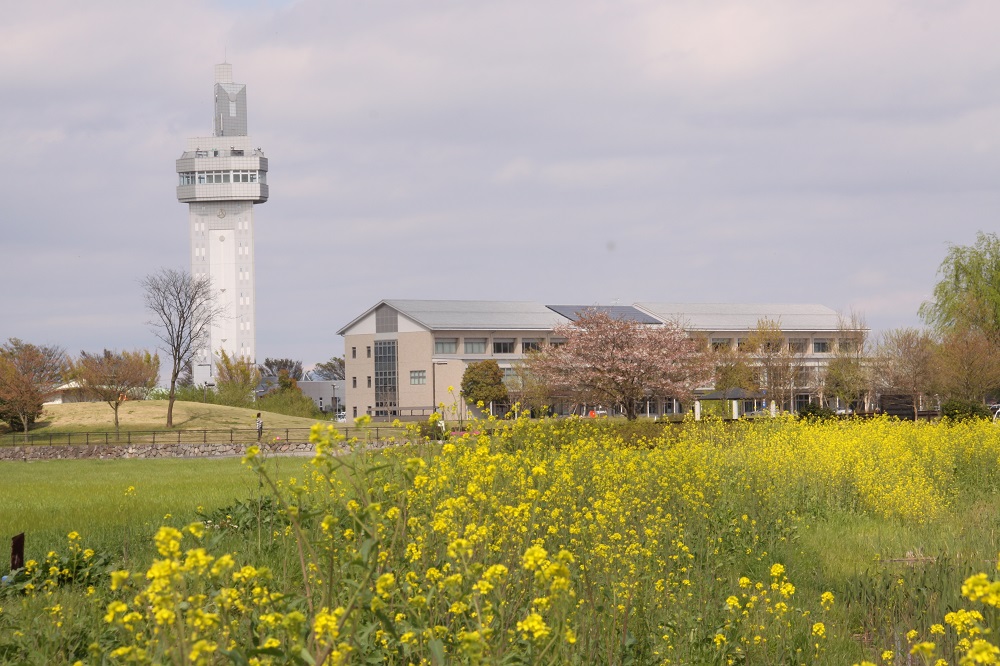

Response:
(0, 426), (402, 446)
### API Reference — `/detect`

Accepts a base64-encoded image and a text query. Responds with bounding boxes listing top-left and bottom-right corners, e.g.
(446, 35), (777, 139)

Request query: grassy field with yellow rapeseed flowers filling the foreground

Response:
(0, 419), (1000, 666)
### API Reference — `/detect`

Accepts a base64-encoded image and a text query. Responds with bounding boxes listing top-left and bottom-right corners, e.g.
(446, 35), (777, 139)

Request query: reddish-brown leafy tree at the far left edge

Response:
(0, 338), (68, 437)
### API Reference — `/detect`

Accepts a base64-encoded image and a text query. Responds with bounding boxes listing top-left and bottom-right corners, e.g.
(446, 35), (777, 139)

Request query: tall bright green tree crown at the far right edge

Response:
(920, 231), (1000, 345)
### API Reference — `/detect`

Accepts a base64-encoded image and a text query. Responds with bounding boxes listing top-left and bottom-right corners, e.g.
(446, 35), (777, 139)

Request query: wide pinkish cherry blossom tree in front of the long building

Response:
(525, 310), (712, 420)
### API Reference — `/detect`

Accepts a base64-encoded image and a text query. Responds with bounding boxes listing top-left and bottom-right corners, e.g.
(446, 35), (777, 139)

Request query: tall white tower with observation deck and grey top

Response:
(177, 63), (268, 384)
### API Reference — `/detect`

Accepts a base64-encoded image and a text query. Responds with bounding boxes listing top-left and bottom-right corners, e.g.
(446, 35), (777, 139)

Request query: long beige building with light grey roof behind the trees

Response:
(338, 300), (841, 419)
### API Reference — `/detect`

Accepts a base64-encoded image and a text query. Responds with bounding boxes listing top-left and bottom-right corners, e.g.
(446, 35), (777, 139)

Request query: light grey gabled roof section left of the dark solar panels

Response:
(337, 299), (569, 335)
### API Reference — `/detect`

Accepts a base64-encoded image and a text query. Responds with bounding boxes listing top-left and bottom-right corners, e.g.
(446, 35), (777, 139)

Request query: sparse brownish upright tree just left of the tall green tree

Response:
(876, 328), (935, 419)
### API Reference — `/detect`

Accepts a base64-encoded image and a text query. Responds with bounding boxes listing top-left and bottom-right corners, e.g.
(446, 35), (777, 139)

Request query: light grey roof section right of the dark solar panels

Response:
(635, 302), (840, 331)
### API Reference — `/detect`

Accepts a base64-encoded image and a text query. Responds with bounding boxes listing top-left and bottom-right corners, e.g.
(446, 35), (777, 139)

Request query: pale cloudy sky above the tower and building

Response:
(0, 0), (1000, 367)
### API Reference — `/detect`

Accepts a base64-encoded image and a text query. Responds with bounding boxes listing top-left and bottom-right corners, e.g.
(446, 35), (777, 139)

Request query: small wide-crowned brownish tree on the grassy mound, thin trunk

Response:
(73, 349), (160, 436)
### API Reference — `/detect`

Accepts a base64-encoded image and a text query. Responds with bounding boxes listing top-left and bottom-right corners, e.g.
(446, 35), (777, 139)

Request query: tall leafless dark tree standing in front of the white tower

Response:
(141, 268), (223, 428)
